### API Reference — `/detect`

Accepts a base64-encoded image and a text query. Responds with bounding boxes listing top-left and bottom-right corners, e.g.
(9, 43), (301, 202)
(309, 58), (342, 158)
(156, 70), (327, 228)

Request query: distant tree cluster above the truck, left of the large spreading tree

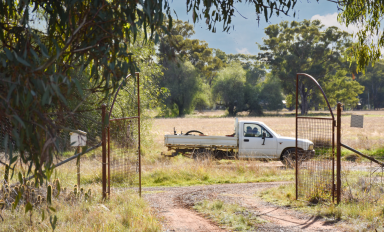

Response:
(158, 20), (284, 116)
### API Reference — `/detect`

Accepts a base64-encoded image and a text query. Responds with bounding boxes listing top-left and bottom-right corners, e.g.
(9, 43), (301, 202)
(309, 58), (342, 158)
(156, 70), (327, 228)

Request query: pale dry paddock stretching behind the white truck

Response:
(143, 111), (384, 164)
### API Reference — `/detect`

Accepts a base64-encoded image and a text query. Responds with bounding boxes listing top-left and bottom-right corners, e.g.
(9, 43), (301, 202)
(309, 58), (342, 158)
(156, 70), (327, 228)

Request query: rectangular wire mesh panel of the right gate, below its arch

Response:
(297, 117), (335, 201)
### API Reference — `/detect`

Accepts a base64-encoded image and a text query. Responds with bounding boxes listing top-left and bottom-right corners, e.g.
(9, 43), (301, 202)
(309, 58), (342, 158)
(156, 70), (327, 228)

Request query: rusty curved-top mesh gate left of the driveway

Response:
(102, 73), (141, 198)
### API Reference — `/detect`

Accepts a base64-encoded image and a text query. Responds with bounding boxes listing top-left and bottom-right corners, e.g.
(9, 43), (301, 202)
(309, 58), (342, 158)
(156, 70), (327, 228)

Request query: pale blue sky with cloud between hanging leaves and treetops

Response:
(170, 0), (356, 55)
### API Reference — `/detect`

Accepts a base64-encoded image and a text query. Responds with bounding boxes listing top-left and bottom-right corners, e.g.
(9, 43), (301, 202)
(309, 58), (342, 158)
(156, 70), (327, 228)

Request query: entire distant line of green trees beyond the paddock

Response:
(157, 20), (384, 116)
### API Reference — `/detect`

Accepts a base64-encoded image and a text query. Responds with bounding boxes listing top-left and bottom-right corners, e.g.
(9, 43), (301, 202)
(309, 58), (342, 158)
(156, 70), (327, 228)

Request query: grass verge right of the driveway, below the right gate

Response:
(260, 184), (384, 231)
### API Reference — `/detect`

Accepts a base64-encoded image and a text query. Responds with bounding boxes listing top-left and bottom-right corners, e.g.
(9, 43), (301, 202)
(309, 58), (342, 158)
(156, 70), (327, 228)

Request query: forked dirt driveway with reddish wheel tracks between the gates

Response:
(143, 182), (342, 232)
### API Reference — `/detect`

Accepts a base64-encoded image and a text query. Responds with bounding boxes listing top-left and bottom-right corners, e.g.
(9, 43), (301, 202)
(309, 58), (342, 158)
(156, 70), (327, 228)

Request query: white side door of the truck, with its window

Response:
(239, 123), (277, 158)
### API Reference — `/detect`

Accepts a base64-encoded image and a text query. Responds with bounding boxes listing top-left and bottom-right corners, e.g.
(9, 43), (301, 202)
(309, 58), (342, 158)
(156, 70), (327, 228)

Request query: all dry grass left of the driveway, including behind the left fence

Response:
(0, 151), (162, 231)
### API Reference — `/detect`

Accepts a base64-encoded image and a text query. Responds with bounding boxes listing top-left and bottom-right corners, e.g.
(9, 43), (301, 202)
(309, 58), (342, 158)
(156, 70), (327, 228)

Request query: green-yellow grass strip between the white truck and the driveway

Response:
(142, 156), (294, 186)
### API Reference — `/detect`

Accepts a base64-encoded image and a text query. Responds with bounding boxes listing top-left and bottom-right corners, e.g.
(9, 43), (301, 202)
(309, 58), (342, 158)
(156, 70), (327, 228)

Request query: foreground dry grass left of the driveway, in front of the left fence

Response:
(0, 188), (161, 231)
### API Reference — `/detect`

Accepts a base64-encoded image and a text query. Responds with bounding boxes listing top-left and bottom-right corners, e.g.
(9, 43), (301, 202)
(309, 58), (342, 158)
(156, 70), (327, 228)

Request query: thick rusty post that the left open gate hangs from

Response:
(101, 104), (107, 199)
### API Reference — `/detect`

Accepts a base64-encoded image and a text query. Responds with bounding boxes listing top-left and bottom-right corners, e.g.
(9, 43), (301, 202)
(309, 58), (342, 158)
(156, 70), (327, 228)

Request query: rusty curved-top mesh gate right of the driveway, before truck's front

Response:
(295, 73), (340, 202)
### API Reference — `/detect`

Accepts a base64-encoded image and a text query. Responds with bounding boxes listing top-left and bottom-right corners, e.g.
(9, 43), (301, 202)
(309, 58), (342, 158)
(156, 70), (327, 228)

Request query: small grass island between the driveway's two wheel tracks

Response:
(193, 200), (265, 231)
